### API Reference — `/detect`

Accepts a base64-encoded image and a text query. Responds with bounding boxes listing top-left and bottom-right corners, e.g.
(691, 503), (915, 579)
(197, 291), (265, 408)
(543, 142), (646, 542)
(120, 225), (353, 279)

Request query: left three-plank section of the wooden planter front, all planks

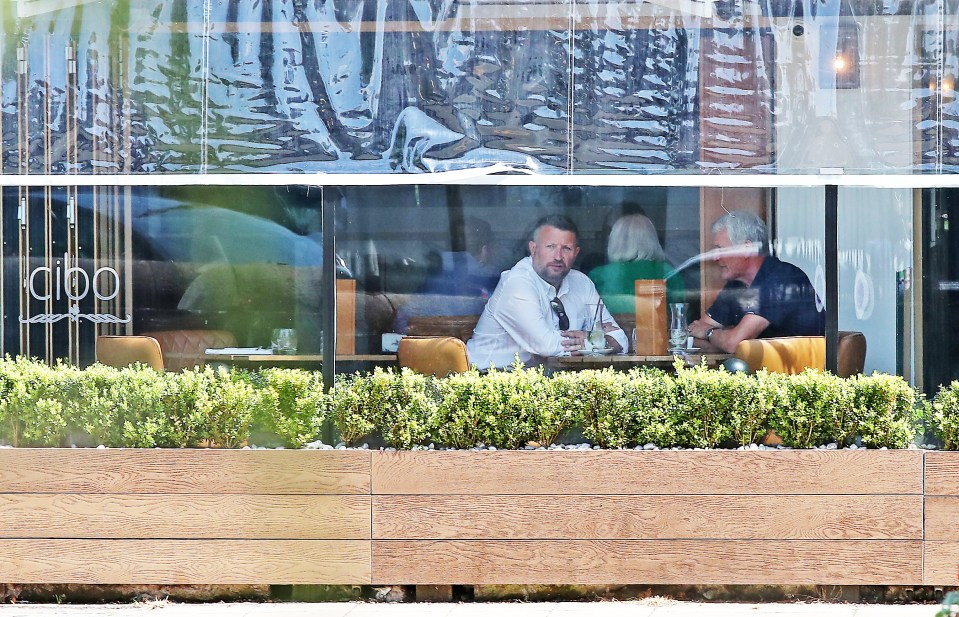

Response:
(0, 449), (372, 584)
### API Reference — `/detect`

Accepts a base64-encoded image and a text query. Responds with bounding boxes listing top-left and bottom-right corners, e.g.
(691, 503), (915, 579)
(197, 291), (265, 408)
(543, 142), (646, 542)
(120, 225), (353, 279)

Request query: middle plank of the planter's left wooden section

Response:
(0, 493), (371, 540)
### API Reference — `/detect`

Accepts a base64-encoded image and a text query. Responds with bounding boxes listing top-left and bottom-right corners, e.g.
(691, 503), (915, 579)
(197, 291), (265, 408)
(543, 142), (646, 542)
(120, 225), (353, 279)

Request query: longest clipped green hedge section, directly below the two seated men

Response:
(330, 366), (923, 448)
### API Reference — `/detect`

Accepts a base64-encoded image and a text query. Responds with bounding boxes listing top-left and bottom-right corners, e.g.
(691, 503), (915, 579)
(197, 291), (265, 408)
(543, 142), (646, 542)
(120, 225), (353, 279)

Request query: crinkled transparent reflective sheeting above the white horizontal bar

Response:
(0, 0), (959, 174)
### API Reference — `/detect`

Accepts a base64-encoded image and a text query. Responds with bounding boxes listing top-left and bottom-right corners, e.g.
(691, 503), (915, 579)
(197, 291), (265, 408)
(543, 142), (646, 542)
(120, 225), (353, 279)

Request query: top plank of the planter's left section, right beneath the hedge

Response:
(0, 448), (370, 495)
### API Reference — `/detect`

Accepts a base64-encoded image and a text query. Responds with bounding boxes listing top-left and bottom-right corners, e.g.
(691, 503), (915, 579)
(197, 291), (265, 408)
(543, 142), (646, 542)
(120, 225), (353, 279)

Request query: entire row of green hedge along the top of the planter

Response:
(0, 358), (959, 449)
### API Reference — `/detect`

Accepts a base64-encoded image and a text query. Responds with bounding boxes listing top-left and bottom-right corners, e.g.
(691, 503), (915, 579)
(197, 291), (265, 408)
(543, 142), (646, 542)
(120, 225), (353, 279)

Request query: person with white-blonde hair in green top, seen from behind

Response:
(589, 214), (685, 314)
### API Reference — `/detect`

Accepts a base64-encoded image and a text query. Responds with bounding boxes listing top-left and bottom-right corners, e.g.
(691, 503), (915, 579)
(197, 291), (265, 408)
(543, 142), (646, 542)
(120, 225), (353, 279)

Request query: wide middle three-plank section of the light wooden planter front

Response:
(372, 450), (923, 585)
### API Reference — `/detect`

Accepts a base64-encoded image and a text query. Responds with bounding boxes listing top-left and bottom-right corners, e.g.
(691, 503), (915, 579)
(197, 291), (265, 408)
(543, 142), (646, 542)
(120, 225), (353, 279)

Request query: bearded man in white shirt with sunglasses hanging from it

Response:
(466, 215), (628, 370)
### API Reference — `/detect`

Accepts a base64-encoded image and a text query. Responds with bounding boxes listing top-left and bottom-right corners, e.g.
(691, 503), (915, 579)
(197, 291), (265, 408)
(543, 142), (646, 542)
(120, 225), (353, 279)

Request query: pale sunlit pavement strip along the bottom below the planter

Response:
(0, 598), (939, 617)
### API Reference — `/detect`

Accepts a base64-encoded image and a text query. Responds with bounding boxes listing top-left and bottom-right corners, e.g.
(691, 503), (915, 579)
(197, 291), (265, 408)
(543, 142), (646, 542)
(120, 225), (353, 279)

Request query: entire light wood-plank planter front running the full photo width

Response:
(0, 449), (959, 585)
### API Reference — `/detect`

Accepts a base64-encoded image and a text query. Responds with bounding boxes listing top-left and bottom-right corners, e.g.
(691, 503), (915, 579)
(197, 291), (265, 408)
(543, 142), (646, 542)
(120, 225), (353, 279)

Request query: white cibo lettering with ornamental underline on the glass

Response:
(20, 253), (130, 323)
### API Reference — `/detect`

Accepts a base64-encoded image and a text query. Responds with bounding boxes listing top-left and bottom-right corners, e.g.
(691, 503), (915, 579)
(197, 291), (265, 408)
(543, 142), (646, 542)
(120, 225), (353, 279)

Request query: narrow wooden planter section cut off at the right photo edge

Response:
(922, 452), (959, 585)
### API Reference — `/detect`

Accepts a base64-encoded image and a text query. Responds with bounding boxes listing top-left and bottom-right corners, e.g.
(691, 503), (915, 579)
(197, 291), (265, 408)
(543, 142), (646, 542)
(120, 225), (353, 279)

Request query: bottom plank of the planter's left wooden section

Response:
(0, 539), (370, 585)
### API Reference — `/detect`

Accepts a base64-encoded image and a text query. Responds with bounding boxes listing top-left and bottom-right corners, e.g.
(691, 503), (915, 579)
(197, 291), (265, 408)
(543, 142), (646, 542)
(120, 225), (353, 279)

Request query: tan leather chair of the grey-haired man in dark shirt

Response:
(735, 332), (866, 377)
